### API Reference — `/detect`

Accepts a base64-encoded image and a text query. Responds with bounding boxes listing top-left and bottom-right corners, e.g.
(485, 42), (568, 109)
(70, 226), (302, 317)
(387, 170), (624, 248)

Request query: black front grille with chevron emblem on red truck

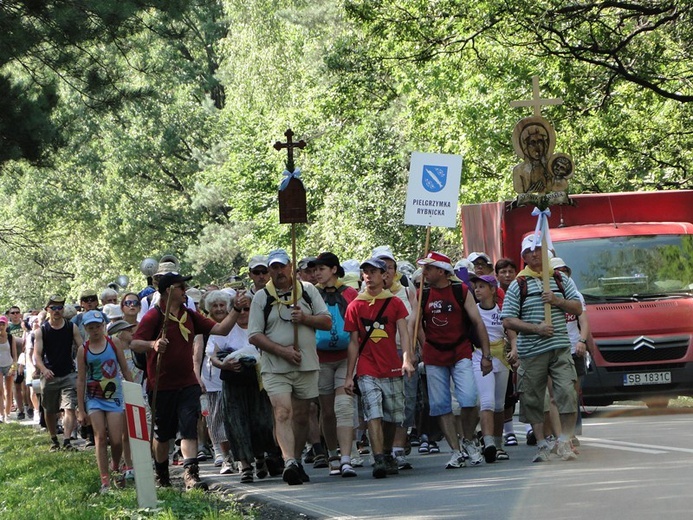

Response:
(597, 336), (690, 363)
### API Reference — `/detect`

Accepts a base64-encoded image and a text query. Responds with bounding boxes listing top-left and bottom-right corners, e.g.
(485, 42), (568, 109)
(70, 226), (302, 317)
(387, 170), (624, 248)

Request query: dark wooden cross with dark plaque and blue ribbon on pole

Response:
(274, 128), (308, 350)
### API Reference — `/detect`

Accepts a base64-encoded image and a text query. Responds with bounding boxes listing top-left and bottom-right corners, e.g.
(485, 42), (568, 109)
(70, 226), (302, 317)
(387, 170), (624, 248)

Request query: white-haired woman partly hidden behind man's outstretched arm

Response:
(195, 290), (233, 475)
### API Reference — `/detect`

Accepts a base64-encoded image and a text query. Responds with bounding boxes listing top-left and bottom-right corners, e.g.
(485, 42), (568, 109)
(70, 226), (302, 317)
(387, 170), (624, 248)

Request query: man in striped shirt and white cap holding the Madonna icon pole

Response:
(501, 233), (582, 462)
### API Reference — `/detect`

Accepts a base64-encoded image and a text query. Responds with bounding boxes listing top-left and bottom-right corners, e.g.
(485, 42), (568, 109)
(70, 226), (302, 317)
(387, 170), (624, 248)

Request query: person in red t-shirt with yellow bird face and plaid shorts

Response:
(344, 258), (414, 478)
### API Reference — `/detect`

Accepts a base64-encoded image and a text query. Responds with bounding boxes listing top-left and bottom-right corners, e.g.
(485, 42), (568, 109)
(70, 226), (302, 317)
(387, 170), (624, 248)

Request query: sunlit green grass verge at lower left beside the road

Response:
(0, 423), (248, 520)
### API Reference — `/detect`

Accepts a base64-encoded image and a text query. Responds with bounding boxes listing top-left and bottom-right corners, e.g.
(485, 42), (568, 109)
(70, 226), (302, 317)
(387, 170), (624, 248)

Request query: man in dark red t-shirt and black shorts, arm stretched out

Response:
(131, 272), (243, 490)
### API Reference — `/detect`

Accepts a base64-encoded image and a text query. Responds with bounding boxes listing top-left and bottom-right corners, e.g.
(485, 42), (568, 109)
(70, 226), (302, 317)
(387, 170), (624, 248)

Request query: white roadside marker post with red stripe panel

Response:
(123, 381), (157, 509)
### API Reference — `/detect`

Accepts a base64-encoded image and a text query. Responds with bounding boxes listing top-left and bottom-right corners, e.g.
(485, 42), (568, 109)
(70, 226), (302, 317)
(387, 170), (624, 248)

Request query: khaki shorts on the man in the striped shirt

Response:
(517, 348), (577, 424)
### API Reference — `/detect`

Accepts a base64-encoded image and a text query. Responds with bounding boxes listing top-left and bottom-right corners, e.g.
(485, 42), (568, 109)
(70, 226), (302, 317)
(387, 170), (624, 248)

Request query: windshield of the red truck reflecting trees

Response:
(554, 235), (693, 300)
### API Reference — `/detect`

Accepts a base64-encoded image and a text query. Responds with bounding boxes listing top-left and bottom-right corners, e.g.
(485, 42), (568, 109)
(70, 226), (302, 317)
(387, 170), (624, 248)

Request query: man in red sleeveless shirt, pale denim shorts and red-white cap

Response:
(417, 251), (493, 469)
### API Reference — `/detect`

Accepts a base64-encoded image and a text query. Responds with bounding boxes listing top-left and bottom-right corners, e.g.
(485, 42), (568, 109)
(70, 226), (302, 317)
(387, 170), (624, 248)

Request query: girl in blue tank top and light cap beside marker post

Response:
(77, 311), (132, 493)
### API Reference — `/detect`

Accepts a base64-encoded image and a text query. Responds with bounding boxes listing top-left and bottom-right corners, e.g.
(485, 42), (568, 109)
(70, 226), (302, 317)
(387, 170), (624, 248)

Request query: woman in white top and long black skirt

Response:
(207, 292), (275, 484)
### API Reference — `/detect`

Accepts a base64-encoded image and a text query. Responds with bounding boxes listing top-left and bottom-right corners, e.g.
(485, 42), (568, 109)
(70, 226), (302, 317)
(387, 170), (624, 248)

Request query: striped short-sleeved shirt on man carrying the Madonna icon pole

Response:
(501, 273), (580, 358)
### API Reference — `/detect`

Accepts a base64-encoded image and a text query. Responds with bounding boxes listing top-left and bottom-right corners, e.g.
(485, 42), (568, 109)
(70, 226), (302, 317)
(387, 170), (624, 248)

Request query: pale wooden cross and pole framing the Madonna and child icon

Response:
(510, 76), (570, 325)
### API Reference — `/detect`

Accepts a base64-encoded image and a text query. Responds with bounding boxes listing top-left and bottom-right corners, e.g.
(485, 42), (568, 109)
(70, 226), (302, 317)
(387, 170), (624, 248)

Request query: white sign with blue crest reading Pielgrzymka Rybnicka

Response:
(404, 152), (462, 227)
